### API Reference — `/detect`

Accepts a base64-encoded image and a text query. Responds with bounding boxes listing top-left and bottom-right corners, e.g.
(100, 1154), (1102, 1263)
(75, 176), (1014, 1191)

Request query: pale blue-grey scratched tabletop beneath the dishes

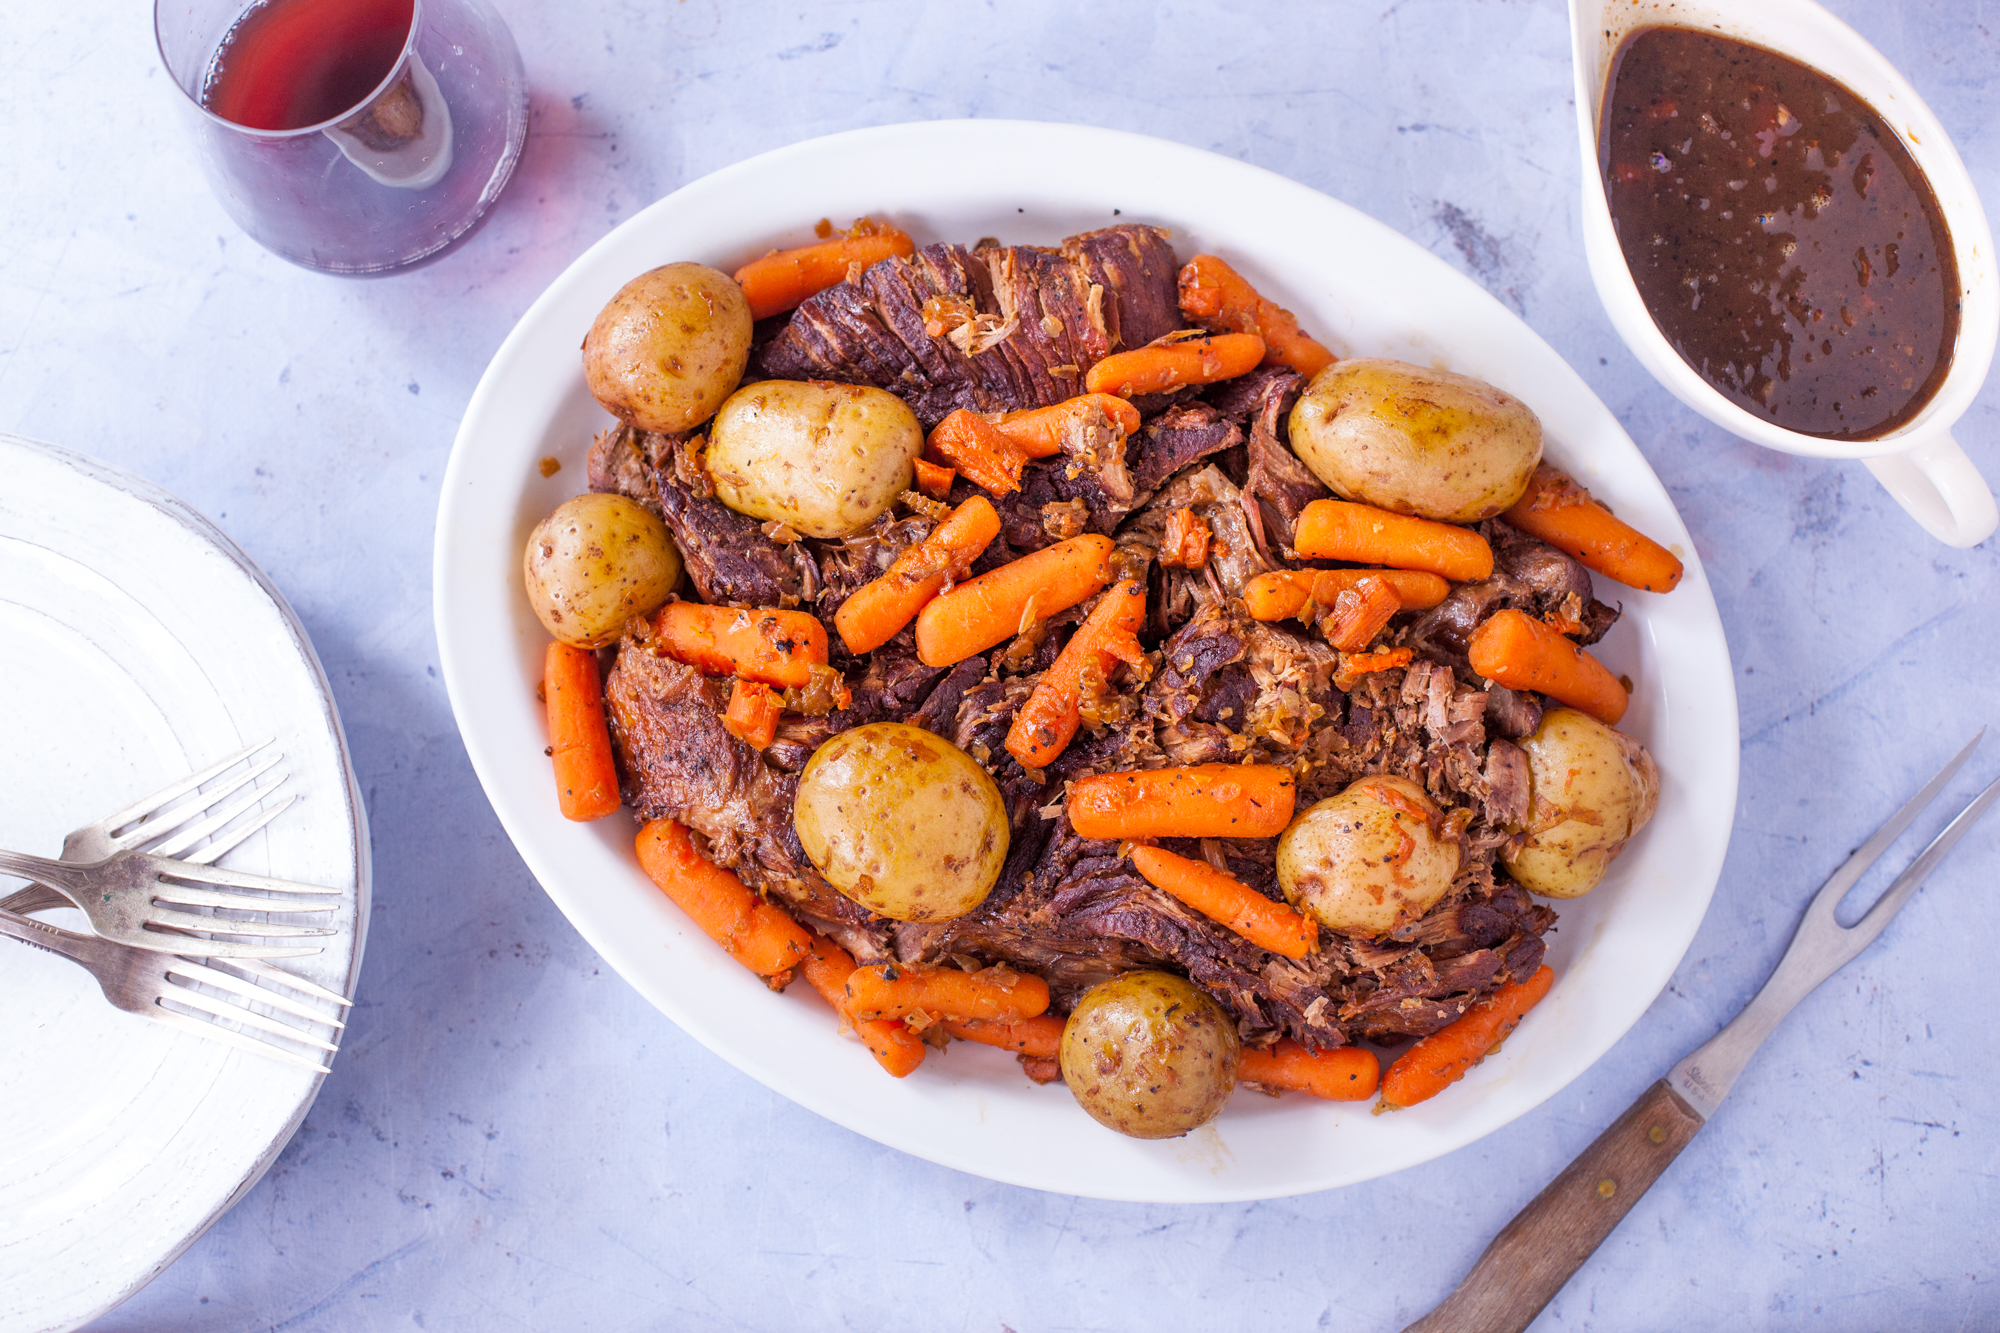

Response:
(0, 0), (2000, 1333)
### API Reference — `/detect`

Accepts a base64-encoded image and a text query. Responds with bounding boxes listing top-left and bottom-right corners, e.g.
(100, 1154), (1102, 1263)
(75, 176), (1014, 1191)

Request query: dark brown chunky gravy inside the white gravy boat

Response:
(1598, 28), (1960, 440)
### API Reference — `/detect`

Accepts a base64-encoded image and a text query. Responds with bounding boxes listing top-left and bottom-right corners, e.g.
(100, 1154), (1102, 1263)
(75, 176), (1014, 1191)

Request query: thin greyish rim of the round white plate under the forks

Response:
(0, 430), (374, 1327)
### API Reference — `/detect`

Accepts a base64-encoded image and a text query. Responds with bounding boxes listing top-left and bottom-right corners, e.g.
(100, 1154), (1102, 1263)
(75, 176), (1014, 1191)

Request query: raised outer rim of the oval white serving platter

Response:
(432, 120), (1740, 1203)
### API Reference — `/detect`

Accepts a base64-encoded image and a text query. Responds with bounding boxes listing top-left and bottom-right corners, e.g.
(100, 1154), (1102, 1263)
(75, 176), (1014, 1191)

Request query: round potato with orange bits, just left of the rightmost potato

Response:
(1278, 775), (1458, 939)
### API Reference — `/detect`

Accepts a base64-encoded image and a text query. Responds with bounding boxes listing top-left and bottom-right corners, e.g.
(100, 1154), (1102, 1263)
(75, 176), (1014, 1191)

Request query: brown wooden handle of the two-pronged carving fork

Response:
(1404, 1079), (1702, 1333)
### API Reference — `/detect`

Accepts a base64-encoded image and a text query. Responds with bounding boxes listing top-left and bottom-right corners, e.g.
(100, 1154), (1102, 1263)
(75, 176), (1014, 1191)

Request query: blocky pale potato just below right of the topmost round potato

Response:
(708, 380), (924, 536)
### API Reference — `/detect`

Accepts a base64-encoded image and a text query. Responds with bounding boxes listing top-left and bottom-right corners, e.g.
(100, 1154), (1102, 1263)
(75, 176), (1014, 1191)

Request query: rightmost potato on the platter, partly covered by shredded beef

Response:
(1502, 709), (1660, 899)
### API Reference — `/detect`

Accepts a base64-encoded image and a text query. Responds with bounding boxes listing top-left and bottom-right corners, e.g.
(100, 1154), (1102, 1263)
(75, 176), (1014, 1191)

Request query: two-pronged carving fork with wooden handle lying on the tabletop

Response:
(1404, 727), (2000, 1333)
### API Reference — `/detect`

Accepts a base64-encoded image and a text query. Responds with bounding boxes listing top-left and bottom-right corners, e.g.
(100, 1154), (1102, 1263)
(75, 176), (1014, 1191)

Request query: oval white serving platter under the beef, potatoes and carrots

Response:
(434, 120), (1738, 1201)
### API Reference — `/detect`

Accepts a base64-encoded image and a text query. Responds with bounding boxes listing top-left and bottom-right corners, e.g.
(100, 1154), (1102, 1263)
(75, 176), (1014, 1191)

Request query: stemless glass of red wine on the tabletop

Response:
(154, 0), (528, 274)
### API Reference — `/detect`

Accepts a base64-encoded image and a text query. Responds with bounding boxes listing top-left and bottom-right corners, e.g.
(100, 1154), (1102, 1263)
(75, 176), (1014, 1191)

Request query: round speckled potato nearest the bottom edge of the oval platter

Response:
(1060, 971), (1242, 1139)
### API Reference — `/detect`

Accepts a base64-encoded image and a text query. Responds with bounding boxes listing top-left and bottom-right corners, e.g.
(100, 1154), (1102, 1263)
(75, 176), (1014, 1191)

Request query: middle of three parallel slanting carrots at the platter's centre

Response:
(916, 532), (1114, 667)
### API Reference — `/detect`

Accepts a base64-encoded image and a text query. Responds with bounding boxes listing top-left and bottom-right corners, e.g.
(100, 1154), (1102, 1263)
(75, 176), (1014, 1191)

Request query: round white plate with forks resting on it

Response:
(0, 436), (368, 1333)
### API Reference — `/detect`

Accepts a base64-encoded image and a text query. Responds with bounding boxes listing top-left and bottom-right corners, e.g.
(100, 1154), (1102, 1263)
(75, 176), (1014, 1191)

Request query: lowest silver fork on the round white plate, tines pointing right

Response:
(0, 909), (346, 1073)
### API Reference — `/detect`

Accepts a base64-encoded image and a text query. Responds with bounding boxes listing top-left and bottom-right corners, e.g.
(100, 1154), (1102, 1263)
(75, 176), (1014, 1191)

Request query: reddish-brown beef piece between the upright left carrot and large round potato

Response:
(604, 636), (876, 929)
